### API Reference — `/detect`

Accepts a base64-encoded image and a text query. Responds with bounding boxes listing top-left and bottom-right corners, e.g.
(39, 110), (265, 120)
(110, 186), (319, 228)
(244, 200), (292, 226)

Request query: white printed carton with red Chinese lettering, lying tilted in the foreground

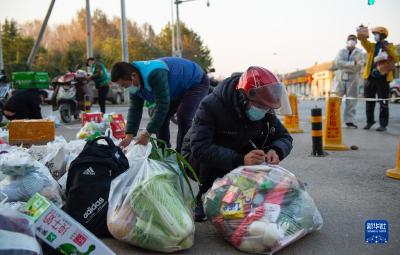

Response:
(24, 193), (115, 255)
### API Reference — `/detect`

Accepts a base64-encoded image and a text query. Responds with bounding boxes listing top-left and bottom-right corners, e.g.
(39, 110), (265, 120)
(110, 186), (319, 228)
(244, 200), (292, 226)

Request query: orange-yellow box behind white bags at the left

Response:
(8, 119), (56, 144)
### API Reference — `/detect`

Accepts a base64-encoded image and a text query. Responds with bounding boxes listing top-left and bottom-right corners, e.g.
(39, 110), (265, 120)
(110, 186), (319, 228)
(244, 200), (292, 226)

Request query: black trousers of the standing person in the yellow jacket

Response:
(364, 77), (390, 127)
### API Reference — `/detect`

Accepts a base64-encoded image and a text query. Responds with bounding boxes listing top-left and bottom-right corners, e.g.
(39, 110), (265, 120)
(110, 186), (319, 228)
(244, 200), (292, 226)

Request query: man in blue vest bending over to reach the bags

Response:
(111, 57), (210, 151)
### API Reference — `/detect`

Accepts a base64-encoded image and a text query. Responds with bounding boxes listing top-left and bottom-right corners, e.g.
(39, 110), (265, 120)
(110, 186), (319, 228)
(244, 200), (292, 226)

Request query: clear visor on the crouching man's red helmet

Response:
(247, 83), (292, 115)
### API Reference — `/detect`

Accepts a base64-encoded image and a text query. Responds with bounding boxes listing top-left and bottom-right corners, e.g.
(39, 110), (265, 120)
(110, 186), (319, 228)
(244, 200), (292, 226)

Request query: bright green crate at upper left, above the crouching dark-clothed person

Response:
(12, 72), (49, 89)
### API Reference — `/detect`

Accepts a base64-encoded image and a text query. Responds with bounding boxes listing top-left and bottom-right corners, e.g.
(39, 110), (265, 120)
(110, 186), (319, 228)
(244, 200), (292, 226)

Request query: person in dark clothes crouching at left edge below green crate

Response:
(3, 89), (44, 120)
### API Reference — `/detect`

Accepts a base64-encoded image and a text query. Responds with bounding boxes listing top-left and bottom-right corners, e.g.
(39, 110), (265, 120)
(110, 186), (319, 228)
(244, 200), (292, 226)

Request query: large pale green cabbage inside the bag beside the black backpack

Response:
(130, 172), (194, 252)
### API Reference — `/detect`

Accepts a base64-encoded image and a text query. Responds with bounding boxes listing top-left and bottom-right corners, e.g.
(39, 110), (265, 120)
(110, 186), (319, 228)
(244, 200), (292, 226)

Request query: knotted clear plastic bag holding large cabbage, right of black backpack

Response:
(107, 144), (195, 252)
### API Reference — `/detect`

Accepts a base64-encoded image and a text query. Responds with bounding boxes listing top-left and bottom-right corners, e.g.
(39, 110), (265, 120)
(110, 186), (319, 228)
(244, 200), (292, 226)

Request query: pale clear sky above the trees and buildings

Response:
(0, 0), (400, 75)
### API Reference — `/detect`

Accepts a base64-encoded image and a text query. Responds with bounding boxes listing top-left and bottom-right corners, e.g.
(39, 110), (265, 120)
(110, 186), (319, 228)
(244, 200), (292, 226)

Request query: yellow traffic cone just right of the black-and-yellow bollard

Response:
(323, 96), (349, 151)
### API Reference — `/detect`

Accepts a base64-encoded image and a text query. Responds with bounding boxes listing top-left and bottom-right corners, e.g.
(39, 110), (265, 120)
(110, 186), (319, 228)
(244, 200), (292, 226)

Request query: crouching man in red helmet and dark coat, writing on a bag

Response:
(182, 67), (292, 221)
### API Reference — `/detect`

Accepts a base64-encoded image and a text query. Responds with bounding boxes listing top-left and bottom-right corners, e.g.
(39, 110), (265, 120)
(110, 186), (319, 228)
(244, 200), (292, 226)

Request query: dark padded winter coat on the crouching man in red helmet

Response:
(182, 76), (293, 173)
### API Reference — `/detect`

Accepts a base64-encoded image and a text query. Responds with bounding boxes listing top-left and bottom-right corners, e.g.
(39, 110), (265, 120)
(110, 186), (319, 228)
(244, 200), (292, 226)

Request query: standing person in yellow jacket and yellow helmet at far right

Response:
(359, 27), (399, 131)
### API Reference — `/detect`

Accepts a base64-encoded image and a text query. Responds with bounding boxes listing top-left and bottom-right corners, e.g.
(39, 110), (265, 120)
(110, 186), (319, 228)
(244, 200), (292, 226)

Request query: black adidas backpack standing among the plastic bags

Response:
(63, 136), (129, 237)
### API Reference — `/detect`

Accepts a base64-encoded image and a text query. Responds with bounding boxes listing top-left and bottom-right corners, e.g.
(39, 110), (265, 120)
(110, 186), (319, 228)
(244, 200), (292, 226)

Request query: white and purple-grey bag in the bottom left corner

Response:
(0, 193), (42, 255)
